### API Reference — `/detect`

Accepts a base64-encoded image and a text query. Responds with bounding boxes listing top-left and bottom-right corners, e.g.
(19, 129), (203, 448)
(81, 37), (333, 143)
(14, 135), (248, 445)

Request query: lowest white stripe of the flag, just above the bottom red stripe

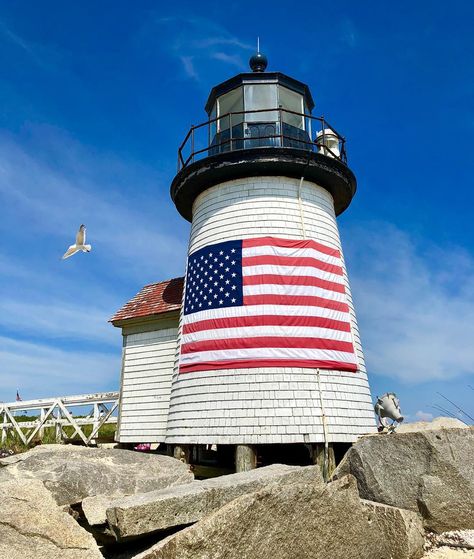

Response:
(180, 347), (357, 369)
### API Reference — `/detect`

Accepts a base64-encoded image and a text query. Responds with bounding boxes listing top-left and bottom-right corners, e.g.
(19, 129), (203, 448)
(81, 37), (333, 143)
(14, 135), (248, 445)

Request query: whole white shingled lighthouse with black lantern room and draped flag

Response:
(166, 53), (375, 470)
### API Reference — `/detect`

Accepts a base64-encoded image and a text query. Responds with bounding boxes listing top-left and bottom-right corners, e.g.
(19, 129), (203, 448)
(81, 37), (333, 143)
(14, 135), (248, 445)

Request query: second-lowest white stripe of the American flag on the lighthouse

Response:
(181, 326), (352, 344)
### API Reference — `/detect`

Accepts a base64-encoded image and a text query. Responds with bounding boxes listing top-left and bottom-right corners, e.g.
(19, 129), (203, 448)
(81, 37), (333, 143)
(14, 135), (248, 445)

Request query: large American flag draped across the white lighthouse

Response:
(179, 237), (357, 373)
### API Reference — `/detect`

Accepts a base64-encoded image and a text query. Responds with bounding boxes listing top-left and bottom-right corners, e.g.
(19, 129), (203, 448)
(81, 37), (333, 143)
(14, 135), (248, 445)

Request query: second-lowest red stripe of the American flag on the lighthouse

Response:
(181, 336), (354, 354)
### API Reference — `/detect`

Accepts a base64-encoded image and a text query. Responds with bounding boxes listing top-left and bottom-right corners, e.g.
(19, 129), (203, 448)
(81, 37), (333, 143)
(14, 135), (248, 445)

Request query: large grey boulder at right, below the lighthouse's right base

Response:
(333, 427), (474, 532)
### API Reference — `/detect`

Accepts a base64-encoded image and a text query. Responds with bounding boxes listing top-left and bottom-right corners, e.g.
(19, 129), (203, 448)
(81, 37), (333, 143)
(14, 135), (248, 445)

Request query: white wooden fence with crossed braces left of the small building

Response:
(0, 392), (119, 445)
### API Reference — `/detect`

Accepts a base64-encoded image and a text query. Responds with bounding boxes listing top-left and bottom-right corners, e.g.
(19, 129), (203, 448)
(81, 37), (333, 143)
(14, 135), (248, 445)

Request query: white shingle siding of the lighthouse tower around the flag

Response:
(166, 177), (375, 444)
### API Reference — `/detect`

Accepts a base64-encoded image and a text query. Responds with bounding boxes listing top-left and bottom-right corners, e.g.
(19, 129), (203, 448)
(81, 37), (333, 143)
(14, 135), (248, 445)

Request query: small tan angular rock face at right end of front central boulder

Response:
(361, 500), (425, 559)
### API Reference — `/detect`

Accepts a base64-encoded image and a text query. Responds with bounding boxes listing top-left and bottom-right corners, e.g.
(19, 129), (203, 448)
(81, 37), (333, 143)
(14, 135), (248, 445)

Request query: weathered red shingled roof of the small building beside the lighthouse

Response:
(109, 278), (184, 323)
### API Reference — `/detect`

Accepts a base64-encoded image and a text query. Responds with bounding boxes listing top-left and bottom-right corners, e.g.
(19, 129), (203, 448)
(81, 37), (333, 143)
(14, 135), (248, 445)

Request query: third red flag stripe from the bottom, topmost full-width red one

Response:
(183, 315), (351, 335)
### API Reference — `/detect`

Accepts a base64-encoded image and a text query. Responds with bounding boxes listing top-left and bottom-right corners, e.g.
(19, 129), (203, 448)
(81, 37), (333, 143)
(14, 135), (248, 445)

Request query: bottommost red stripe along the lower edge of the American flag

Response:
(179, 359), (357, 373)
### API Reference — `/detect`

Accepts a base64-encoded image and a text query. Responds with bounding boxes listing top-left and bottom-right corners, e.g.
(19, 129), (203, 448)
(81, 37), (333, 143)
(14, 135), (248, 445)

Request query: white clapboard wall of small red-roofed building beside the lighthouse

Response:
(117, 322), (178, 443)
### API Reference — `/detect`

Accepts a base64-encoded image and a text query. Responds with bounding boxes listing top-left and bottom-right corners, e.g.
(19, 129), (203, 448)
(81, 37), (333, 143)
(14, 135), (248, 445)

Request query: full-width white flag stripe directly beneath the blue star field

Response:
(183, 305), (350, 324)
